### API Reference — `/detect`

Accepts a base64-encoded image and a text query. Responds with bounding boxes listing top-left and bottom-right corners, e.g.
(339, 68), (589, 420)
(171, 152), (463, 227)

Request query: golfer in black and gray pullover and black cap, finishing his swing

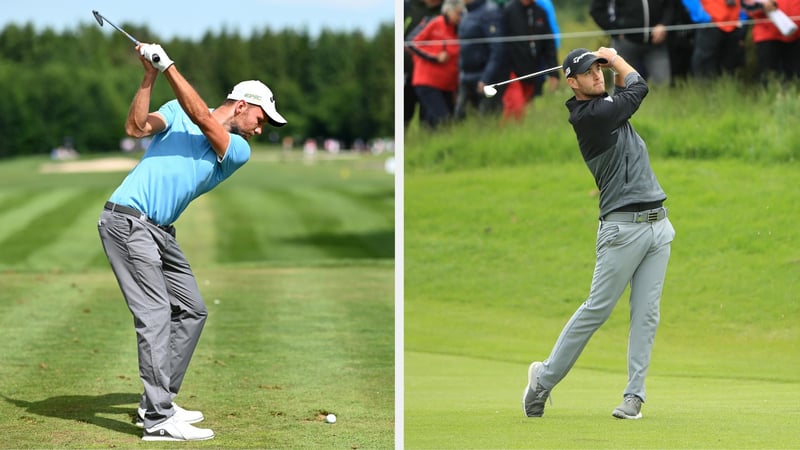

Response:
(522, 47), (675, 419)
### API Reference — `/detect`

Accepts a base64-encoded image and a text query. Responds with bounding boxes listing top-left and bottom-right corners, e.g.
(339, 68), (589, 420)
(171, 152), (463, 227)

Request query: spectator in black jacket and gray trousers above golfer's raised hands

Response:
(589, 0), (680, 85)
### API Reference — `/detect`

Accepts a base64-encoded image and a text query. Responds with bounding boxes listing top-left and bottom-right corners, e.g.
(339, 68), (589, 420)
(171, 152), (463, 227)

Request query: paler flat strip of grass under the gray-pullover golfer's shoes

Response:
(405, 352), (800, 449)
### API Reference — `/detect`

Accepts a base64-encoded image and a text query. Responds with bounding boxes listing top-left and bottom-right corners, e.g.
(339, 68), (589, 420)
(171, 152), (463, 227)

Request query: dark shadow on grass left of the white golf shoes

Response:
(2, 393), (142, 436)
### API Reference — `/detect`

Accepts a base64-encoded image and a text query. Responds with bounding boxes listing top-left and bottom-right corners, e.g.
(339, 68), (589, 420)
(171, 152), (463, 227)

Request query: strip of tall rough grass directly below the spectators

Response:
(404, 77), (800, 172)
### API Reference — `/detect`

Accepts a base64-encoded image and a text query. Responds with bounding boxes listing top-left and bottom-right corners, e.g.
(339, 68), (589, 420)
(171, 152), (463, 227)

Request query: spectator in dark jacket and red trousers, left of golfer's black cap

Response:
(503, 0), (559, 120)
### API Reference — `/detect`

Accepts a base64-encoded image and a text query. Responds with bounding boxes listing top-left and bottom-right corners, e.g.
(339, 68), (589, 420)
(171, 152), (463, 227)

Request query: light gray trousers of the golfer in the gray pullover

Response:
(538, 218), (675, 401)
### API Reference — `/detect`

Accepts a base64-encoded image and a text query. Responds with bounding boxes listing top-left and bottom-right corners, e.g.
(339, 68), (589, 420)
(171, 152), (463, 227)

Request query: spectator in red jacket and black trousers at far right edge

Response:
(742, 0), (800, 82)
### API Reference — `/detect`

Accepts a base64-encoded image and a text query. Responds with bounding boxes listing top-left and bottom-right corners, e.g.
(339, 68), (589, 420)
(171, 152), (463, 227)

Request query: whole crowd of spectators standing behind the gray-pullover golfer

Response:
(404, 0), (800, 129)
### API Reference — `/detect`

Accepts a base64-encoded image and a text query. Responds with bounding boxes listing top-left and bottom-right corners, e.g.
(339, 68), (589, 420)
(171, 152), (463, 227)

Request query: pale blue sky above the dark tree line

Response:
(0, 0), (399, 39)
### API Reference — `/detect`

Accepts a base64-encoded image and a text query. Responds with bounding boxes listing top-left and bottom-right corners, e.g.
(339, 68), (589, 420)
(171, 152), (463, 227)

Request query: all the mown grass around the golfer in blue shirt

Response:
(0, 151), (395, 448)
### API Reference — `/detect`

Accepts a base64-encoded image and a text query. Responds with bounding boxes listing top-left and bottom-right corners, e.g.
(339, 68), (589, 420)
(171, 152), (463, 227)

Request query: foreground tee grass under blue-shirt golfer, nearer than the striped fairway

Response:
(0, 264), (394, 448)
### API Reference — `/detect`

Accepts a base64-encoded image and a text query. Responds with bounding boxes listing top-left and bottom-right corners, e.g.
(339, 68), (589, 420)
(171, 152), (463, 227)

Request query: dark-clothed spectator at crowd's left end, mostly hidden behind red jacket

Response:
(403, 0), (442, 126)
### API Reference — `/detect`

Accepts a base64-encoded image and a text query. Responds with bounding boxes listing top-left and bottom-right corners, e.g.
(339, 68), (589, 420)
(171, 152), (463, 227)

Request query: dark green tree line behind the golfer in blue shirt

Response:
(0, 23), (394, 157)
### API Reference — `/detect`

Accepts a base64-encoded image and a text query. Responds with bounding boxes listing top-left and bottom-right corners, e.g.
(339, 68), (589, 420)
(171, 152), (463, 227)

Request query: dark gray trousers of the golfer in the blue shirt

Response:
(97, 210), (208, 428)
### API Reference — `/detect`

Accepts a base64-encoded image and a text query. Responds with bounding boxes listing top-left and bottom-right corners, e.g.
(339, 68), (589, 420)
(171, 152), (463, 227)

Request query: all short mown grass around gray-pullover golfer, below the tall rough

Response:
(404, 159), (800, 448)
